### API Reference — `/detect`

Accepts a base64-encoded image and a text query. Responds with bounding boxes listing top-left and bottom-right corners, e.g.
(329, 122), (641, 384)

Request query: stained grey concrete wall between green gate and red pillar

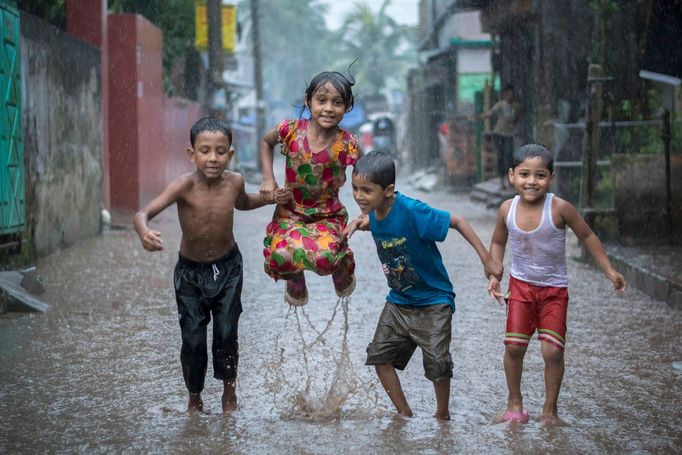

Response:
(21, 13), (103, 256)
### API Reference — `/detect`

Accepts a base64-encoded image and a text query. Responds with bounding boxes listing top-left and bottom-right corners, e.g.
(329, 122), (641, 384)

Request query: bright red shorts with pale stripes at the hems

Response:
(504, 277), (568, 351)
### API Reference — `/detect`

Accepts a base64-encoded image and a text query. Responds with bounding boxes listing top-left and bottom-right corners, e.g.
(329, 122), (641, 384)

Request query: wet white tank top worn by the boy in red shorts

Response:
(507, 193), (568, 288)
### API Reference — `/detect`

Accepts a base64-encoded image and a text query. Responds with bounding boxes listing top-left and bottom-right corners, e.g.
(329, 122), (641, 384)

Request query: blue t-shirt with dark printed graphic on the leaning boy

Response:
(369, 193), (455, 311)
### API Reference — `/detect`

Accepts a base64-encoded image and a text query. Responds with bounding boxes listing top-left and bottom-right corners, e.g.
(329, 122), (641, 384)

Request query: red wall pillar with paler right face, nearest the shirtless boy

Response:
(109, 14), (165, 211)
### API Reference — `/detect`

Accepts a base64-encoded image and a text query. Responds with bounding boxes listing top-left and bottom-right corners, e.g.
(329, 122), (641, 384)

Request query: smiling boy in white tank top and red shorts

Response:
(488, 144), (626, 424)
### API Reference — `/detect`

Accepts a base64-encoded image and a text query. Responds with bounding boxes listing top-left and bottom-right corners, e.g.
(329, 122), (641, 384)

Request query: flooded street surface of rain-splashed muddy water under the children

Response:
(0, 173), (682, 454)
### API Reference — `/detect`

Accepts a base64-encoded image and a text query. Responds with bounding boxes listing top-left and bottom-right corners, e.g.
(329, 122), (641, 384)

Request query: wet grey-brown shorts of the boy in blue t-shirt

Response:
(365, 302), (453, 381)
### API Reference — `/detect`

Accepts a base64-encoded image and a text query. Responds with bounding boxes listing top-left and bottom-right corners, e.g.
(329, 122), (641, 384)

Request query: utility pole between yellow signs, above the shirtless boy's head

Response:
(206, 0), (229, 118)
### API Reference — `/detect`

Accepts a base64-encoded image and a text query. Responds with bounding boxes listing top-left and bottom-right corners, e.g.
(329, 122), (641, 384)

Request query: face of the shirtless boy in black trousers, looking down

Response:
(187, 131), (234, 180)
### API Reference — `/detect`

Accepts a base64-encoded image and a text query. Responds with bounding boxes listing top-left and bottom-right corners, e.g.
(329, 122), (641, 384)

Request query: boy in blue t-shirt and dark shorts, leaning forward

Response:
(344, 151), (502, 420)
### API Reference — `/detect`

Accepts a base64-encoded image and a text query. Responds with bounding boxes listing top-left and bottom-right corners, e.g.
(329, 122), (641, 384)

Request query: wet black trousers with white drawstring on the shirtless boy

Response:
(174, 245), (243, 393)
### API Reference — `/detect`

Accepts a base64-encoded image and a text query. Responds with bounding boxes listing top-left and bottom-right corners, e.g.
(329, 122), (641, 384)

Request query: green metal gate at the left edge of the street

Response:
(0, 0), (24, 239)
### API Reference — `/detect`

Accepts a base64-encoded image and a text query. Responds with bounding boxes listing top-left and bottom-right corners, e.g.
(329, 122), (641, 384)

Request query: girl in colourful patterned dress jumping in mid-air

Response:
(260, 71), (362, 306)
